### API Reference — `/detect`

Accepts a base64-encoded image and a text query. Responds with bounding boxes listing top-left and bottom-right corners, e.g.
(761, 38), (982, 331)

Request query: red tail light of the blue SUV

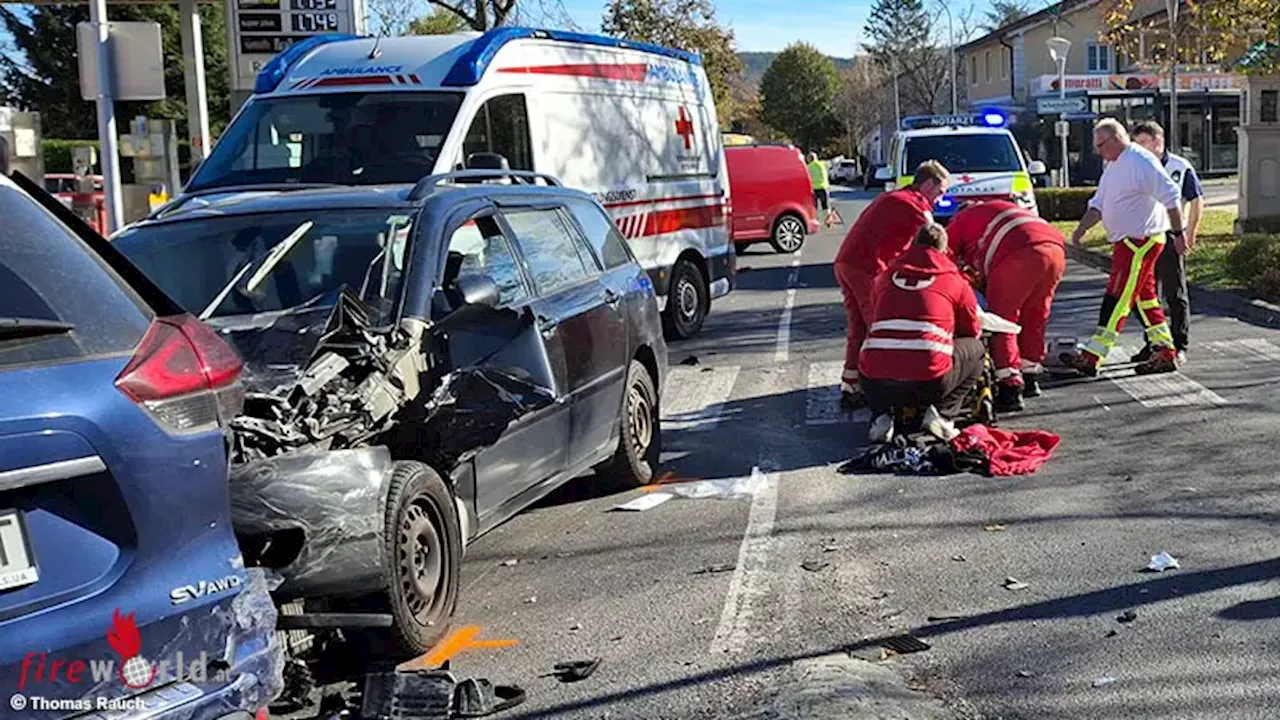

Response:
(115, 310), (244, 432)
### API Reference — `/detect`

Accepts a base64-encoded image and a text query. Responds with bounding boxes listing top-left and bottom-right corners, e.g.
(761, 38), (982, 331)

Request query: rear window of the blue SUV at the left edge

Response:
(0, 181), (151, 369)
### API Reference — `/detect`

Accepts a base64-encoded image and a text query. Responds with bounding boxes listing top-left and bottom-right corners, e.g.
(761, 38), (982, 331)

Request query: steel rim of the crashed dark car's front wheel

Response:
(397, 496), (447, 625)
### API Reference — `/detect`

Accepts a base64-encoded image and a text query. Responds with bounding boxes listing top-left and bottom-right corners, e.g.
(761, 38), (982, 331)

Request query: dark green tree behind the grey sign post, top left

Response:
(0, 4), (230, 140)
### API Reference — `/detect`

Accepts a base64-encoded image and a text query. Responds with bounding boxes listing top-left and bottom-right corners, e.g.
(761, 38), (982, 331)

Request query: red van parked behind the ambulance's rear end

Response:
(724, 145), (820, 252)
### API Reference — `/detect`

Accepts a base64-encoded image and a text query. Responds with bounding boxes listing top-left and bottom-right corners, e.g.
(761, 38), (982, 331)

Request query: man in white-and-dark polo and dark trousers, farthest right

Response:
(1130, 120), (1204, 365)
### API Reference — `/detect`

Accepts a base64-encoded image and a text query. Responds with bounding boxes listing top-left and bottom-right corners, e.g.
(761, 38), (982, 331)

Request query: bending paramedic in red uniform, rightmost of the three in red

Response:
(947, 200), (1066, 413)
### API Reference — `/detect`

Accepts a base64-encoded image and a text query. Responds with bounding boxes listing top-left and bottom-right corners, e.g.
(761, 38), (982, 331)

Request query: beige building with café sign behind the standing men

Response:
(957, 0), (1242, 184)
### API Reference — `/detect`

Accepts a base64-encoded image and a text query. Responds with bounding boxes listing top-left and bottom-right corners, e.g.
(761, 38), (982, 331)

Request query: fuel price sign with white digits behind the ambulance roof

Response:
(227, 0), (365, 92)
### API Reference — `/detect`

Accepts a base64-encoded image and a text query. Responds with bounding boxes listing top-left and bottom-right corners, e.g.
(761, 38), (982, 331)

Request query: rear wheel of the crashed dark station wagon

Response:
(596, 360), (662, 488)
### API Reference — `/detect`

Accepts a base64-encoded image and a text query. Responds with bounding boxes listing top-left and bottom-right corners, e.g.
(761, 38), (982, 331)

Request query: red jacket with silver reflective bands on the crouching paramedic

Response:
(859, 245), (982, 382)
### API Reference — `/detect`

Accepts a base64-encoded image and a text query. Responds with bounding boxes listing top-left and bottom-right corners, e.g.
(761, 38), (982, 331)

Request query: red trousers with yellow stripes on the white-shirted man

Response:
(1084, 233), (1174, 363)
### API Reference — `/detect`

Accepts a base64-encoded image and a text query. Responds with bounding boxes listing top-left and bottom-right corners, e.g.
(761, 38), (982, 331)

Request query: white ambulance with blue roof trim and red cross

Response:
(185, 27), (735, 338)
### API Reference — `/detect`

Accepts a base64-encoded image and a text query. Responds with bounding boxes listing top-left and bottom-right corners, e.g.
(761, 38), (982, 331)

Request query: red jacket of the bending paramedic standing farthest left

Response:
(836, 187), (933, 272)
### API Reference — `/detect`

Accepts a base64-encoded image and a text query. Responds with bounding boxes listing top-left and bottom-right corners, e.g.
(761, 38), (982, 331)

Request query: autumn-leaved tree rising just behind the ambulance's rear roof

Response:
(600, 0), (744, 126)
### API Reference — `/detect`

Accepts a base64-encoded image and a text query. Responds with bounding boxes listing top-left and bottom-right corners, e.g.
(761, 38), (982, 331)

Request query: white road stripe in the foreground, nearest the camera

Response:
(710, 461), (778, 655)
